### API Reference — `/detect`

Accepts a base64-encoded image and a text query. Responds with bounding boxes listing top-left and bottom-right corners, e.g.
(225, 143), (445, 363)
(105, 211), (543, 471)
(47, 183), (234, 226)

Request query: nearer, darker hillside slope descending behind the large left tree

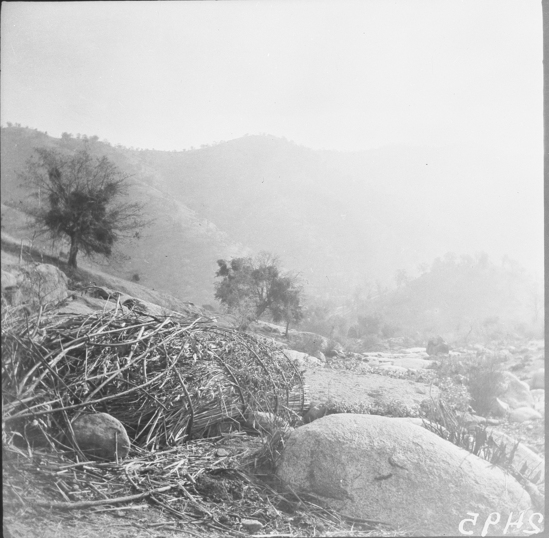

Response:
(1, 128), (249, 303)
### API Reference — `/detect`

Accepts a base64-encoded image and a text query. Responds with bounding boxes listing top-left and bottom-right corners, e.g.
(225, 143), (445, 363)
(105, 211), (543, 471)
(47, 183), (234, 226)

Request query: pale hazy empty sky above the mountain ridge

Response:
(1, 0), (543, 153)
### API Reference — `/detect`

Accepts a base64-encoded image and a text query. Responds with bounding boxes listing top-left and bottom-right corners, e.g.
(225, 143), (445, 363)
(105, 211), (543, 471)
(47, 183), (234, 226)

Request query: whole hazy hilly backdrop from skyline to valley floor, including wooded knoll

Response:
(1, 126), (543, 339)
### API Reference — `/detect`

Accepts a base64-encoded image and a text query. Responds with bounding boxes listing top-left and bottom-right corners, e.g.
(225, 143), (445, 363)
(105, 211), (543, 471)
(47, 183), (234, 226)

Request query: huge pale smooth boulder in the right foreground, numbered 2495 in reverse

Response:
(277, 414), (532, 536)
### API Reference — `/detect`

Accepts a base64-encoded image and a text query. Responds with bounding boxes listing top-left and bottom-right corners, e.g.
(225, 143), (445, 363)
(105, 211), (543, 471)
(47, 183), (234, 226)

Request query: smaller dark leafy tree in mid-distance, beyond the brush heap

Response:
(215, 253), (303, 333)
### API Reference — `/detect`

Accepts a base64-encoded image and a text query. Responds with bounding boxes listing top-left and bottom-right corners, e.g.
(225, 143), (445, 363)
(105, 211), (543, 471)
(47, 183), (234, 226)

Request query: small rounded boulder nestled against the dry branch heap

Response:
(72, 413), (130, 461)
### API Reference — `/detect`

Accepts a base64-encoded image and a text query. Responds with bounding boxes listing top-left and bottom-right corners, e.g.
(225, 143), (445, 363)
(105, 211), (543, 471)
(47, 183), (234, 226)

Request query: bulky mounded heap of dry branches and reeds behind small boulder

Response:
(2, 308), (309, 449)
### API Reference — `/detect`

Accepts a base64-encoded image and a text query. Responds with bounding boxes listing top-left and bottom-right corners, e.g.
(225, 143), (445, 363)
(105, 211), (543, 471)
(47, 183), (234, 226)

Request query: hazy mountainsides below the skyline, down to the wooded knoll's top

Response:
(2, 127), (543, 302)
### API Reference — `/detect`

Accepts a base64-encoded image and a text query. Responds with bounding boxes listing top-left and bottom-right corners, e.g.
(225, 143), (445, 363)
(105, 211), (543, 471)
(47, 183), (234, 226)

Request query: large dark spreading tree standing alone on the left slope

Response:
(19, 148), (148, 268)
